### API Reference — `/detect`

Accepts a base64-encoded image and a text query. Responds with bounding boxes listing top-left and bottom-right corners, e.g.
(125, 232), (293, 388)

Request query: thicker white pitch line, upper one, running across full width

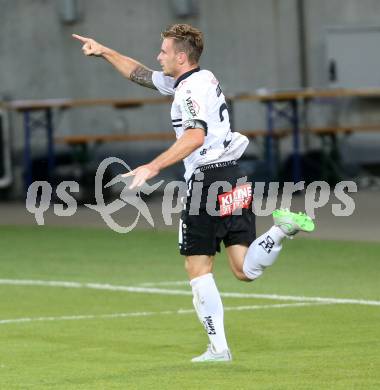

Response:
(0, 279), (380, 306)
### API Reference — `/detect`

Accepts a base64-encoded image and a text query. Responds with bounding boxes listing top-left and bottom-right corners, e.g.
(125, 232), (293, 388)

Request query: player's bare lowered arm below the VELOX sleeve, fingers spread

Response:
(123, 129), (205, 189)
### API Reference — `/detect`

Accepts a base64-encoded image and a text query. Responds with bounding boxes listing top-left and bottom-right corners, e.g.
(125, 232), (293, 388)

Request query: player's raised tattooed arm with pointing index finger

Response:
(72, 34), (157, 89)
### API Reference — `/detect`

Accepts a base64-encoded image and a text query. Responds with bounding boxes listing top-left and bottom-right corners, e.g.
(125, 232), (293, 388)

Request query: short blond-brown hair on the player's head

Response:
(161, 24), (203, 64)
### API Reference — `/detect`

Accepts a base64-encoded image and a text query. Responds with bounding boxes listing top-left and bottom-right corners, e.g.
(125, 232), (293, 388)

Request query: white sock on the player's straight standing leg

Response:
(190, 273), (228, 352)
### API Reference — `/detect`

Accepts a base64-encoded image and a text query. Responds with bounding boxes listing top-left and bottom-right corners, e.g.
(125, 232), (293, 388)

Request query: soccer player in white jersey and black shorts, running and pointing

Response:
(73, 24), (314, 362)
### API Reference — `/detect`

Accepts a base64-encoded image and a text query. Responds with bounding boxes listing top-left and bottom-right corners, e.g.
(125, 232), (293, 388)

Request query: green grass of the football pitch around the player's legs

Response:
(0, 227), (380, 390)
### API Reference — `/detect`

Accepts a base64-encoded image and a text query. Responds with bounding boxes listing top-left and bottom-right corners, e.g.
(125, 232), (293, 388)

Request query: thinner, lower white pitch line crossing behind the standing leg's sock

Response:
(0, 302), (325, 325)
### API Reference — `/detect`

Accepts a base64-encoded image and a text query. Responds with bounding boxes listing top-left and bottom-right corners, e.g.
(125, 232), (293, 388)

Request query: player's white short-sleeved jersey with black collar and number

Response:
(152, 68), (249, 181)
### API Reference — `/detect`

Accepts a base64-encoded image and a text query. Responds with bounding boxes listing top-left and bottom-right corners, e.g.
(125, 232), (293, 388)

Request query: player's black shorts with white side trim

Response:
(179, 162), (256, 256)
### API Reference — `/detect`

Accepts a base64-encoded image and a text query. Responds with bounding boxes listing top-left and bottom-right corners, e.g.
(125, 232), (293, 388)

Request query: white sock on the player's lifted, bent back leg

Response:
(243, 226), (286, 280)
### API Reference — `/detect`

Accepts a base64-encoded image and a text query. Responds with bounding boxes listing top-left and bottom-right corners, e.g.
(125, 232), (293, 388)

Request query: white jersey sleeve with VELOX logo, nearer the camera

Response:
(179, 83), (208, 134)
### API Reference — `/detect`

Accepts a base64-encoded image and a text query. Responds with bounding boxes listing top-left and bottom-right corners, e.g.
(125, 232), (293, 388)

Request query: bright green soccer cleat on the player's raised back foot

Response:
(272, 209), (315, 236)
